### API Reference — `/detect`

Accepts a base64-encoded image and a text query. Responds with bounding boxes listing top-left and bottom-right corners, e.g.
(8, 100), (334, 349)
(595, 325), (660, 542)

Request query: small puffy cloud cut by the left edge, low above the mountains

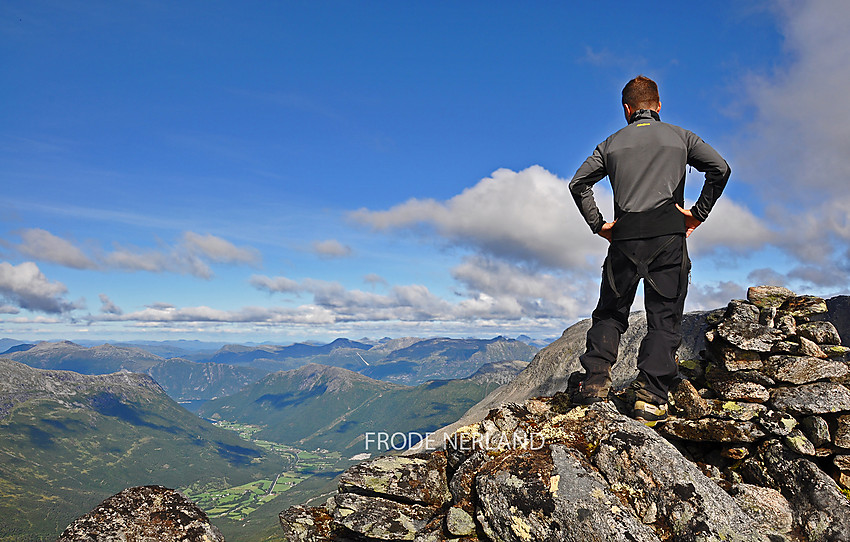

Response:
(0, 262), (81, 313)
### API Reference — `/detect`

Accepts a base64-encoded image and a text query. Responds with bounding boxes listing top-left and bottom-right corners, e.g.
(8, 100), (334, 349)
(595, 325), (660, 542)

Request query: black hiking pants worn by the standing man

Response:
(579, 234), (690, 404)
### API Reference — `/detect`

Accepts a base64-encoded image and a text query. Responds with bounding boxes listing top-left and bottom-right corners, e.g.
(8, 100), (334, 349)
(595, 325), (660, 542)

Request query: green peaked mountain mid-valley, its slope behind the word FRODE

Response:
(199, 361), (527, 455)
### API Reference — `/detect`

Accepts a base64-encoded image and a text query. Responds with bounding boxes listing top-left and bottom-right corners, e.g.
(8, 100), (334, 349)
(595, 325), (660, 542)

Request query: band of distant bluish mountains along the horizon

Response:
(0, 337), (537, 401)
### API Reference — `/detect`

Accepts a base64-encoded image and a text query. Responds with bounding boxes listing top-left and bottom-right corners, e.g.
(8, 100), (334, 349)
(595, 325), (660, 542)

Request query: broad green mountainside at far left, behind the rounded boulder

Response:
(0, 358), (287, 542)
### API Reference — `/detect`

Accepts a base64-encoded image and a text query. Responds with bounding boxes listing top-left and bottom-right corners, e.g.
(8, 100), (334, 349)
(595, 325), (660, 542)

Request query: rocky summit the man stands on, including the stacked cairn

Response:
(280, 287), (850, 542)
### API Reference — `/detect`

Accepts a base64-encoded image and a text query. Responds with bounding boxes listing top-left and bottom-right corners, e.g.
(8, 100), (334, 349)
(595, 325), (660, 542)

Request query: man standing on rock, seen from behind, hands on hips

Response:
(570, 75), (730, 425)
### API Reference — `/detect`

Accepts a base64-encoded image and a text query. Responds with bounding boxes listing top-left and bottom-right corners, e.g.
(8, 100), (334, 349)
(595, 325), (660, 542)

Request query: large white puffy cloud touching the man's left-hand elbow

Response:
(351, 166), (612, 269)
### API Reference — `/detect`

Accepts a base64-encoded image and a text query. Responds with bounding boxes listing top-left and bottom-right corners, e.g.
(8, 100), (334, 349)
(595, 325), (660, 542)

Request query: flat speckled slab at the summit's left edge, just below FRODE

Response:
(339, 452), (452, 506)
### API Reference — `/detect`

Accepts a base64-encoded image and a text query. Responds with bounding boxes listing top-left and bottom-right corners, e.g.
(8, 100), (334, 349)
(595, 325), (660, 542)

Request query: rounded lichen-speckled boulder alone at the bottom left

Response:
(57, 486), (224, 542)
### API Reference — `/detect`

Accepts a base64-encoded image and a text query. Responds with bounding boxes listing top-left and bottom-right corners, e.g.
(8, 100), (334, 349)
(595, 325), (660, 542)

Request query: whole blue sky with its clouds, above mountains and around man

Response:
(0, 0), (850, 342)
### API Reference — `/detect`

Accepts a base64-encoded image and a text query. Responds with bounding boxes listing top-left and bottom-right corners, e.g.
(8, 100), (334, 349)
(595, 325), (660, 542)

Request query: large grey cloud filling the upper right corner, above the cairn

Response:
(733, 0), (850, 286)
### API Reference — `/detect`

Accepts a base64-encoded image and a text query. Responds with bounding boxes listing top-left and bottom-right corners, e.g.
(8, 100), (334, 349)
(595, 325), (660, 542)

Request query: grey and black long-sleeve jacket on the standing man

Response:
(570, 109), (731, 240)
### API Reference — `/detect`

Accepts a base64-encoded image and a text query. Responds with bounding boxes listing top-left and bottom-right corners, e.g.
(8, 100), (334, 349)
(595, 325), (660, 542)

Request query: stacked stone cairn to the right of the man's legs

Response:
(660, 286), (850, 500)
